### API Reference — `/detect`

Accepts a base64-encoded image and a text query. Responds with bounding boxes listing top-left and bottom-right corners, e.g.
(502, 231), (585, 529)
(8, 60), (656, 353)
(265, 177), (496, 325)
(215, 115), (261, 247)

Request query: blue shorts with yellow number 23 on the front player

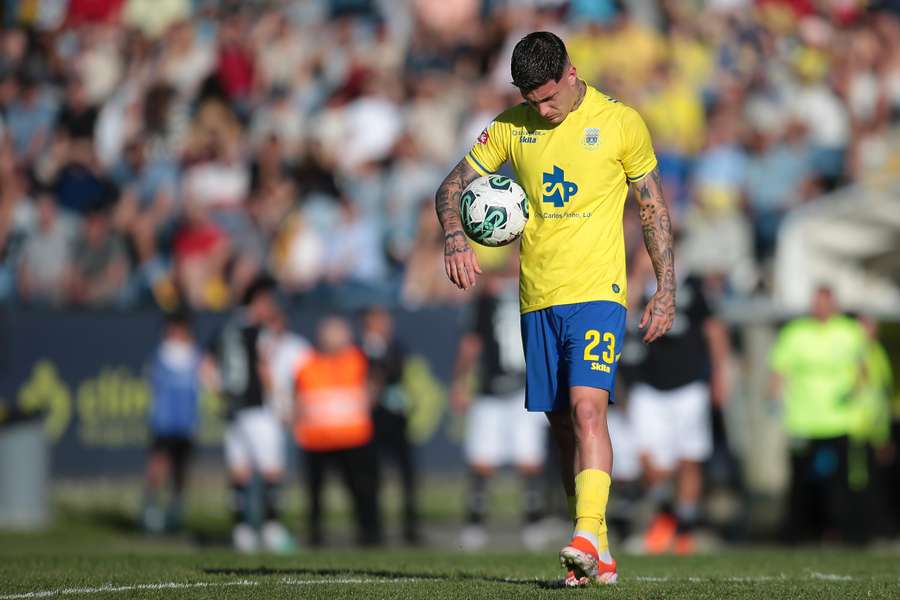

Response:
(522, 300), (626, 412)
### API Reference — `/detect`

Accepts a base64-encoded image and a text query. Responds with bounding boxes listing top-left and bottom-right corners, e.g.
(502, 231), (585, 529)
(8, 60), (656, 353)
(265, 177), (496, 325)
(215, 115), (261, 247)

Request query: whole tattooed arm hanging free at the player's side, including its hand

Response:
(631, 168), (675, 343)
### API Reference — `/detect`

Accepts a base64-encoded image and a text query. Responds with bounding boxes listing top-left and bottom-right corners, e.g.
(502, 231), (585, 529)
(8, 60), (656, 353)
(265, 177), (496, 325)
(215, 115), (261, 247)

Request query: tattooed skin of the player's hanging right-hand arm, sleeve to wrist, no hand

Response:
(632, 168), (675, 308)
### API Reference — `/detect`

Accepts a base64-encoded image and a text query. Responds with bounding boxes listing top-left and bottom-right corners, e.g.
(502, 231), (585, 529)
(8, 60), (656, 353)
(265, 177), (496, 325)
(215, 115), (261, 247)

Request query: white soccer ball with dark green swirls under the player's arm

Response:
(459, 175), (528, 246)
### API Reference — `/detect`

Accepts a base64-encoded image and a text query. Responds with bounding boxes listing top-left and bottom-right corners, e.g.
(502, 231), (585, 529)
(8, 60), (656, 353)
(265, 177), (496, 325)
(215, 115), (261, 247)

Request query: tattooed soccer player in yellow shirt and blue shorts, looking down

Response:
(435, 32), (675, 586)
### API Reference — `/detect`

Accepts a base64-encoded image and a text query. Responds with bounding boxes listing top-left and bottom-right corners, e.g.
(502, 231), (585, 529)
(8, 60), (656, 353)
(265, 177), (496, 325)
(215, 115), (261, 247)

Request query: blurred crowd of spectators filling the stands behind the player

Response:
(0, 0), (900, 310)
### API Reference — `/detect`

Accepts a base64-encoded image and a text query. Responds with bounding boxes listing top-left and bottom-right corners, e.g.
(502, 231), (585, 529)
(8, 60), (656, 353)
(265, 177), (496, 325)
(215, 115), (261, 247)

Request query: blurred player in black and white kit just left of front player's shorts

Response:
(451, 270), (547, 550)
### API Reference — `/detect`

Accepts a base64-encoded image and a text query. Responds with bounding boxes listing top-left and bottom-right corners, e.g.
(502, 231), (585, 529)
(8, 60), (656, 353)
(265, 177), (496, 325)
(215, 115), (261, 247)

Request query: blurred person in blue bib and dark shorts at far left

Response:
(141, 312), (203, 533)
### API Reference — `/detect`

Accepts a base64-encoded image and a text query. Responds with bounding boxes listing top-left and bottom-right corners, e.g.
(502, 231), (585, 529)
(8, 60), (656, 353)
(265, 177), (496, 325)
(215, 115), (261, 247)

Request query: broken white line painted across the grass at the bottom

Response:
(0, 571), (855, 600)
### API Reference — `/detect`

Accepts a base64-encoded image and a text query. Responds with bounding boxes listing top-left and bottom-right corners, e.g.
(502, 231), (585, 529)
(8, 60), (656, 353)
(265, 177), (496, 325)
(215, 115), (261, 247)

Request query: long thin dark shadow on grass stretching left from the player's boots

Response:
(203, 567), (566, 590)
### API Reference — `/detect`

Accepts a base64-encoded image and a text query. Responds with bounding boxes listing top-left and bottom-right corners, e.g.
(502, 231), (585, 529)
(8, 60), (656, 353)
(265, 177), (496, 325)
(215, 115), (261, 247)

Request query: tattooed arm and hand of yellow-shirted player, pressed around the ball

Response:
(434, 159), (481, 290)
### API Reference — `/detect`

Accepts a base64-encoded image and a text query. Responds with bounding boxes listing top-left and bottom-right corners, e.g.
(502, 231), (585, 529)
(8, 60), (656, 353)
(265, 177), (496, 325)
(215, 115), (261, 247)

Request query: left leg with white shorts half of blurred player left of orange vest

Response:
(224, 410), (259, 552)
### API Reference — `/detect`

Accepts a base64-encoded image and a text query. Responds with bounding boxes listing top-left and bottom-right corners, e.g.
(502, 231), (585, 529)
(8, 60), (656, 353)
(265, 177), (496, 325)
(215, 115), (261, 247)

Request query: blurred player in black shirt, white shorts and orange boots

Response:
(622, 255), (730, 554)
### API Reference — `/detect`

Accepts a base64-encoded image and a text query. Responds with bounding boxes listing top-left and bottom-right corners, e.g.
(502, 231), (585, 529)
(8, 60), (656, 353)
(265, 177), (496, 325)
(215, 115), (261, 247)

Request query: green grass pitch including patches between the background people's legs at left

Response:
(0, 475), (900, 600)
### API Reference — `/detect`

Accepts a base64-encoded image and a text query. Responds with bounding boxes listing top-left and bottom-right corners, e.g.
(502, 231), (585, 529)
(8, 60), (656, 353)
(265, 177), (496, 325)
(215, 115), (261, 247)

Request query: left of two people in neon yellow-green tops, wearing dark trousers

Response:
(769, 285), (869, 543)
